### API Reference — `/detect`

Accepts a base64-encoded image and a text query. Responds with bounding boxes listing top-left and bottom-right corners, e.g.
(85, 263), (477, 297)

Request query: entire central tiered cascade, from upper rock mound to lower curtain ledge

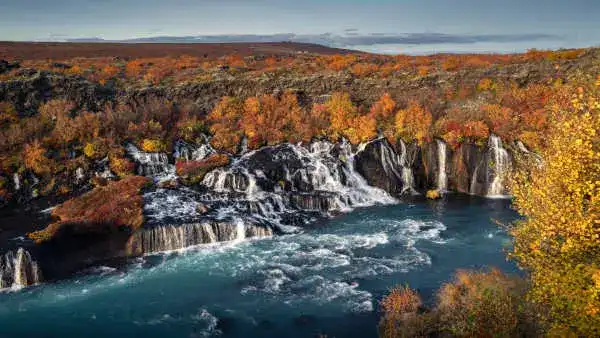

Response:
(139, 142), (398, 253)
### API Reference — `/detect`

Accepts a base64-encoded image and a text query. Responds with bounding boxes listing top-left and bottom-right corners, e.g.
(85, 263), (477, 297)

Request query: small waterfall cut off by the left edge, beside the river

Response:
(0, 248), (42, 289)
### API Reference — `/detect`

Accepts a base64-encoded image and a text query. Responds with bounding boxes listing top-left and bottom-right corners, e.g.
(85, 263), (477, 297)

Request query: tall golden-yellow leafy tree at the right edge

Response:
(511, 88), (600, 337)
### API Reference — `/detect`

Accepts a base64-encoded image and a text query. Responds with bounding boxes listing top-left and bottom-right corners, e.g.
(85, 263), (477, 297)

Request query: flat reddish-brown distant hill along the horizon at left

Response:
(0, 41), (360, 60)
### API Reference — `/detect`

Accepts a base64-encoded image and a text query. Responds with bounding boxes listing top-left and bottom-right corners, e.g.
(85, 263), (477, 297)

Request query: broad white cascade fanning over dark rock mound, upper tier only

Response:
(203, 141), (395, 211)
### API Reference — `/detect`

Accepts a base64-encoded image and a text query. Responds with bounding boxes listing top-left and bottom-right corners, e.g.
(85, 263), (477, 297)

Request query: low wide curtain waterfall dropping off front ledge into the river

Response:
(129, 220), (273, 254)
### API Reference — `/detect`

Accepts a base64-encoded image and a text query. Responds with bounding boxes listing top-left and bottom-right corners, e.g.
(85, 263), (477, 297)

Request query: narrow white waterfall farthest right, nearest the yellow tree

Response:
(487, 135), (511, 196)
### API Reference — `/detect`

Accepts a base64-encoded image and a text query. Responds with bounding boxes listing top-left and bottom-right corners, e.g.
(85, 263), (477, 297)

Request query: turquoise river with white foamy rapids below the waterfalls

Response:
(0, 200), (512, 338)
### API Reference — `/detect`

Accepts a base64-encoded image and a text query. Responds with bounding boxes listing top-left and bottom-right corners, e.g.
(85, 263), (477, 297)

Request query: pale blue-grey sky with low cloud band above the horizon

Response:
(0, 0), (600, 54)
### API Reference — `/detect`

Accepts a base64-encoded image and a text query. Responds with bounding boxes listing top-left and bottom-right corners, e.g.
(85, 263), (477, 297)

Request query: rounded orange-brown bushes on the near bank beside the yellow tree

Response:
(379, 269), (539, 337)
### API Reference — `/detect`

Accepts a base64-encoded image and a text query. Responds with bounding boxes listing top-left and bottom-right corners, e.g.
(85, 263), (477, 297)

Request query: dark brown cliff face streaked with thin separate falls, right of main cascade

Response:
(356, 135), (523, 197)
